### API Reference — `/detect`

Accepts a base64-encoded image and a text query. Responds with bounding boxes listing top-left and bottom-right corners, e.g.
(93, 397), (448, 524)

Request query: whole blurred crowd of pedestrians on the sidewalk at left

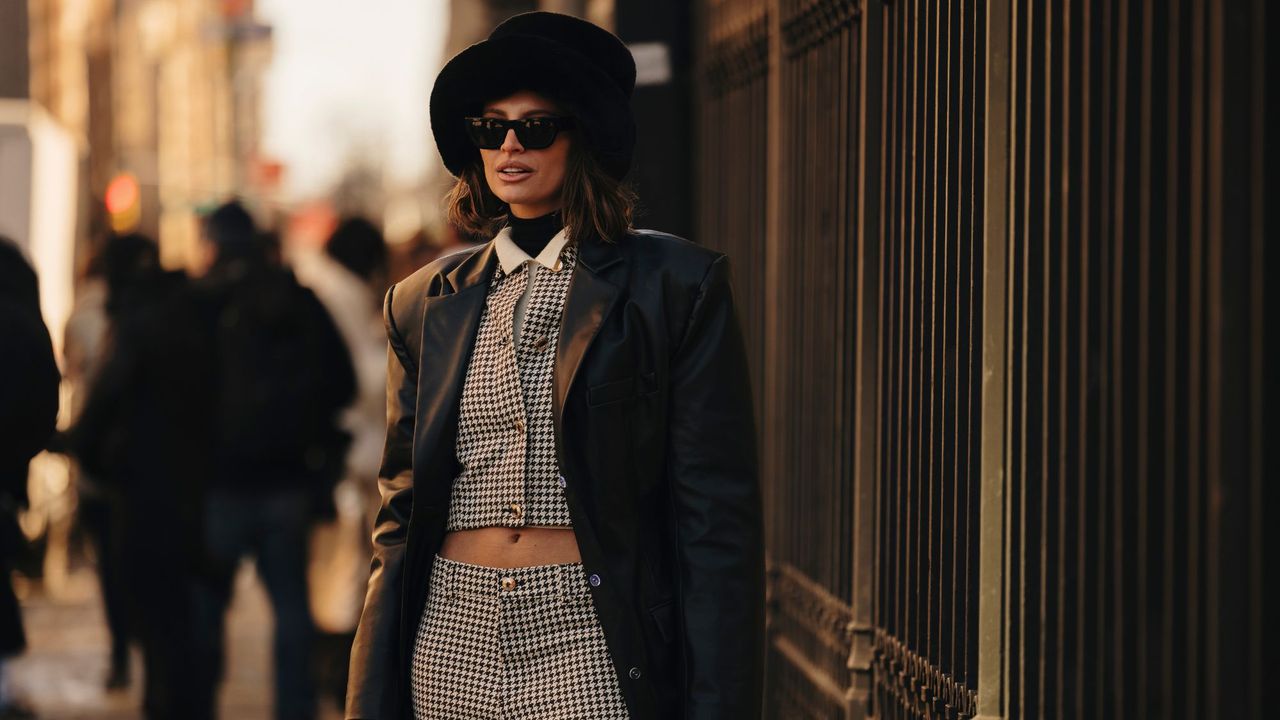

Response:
(0, 201), (460, 719)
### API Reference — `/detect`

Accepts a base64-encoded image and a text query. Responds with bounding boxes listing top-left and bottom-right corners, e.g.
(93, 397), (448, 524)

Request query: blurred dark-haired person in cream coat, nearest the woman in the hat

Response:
(293, 212), (387, 710)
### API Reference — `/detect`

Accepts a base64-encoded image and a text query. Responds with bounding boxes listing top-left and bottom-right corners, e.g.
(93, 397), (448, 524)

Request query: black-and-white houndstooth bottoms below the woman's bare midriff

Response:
(410, 555), (628, 720)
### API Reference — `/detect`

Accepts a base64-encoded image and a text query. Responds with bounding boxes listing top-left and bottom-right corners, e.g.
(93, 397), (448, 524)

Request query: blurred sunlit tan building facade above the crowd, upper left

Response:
(3, 0), (271, 279)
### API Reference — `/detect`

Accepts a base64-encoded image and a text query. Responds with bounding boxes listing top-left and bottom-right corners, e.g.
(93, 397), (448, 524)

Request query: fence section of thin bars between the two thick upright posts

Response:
(868, 0), (986, 717)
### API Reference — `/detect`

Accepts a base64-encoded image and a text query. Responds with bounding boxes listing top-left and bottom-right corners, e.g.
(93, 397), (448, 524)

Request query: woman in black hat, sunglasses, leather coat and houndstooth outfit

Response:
(347, 13), (764, 720)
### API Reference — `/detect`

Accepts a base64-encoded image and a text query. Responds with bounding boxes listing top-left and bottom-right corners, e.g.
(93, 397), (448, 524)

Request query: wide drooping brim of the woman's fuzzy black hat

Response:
(430, 35), (635, 178)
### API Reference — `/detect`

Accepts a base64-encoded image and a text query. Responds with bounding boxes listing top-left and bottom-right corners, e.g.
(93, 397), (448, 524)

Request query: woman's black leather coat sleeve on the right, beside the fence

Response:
(668, 255), (764, 720)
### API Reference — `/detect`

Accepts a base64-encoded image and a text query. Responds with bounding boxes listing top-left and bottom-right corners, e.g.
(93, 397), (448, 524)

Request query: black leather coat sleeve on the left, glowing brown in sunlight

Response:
(347, 286), (417, 720)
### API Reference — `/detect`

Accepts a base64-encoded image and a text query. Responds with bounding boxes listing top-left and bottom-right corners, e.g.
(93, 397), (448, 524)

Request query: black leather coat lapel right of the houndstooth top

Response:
(552, 238), (626, 428)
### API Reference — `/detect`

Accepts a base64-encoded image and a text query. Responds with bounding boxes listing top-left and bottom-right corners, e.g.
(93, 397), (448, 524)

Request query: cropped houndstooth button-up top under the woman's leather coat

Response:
(445, 243), (577, 530)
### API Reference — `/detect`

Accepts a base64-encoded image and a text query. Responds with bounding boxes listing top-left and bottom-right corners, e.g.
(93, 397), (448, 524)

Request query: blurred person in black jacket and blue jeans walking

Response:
(192, 201), (355, 719)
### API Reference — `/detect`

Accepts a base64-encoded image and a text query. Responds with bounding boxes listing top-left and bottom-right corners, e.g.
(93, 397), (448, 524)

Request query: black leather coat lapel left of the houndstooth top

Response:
(413, 242), (498, 497)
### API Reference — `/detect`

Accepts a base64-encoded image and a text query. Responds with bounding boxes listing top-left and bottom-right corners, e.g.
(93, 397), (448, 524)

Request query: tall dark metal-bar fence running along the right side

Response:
(695, 0), (1276, 719)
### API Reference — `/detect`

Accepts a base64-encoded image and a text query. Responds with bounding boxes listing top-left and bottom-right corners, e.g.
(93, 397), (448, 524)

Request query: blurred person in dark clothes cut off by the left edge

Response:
(0, 236), (60, 720)
